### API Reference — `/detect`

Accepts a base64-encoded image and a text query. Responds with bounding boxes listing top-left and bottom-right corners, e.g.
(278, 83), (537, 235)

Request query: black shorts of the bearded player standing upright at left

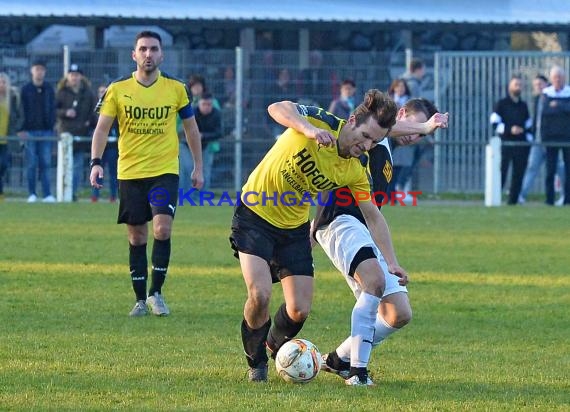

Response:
(117, 173), (178, 225)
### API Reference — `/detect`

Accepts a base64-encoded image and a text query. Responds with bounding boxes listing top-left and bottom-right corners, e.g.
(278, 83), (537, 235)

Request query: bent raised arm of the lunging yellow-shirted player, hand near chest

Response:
(267, 100), (335, 146)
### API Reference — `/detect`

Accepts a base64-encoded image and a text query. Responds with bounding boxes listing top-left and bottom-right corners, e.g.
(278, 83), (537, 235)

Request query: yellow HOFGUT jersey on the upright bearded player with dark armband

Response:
(97, 73), (194, 180)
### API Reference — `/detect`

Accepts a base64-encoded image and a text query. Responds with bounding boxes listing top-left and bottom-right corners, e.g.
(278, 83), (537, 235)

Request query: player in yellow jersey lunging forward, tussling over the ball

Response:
(230, 89), (446, 382)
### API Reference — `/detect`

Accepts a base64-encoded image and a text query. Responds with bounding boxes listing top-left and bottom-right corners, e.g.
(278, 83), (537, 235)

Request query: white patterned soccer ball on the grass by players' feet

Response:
(275, 339), (321, 383)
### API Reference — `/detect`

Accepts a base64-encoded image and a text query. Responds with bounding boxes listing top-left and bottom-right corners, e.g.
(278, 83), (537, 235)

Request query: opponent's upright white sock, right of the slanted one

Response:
(350, 292), (380, 368)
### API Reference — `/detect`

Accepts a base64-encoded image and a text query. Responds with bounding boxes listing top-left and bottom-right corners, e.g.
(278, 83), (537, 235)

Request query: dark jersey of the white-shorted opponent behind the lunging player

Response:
(316, 139), (393, 227)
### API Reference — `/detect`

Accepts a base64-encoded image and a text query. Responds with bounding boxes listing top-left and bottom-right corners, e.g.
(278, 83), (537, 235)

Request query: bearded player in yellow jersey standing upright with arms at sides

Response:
(90, 31), (204, 316)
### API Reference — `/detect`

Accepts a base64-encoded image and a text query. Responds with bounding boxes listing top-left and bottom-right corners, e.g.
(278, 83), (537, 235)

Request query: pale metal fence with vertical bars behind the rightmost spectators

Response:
(433, 52), (570, 193)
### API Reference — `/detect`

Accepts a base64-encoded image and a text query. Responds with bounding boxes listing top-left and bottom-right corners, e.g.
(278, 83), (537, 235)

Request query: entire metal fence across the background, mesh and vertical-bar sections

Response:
(0, 48), (570, 197)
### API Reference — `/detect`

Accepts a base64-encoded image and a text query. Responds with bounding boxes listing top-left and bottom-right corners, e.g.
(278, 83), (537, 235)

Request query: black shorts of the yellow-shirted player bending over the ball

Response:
(230, 205), (314, 282)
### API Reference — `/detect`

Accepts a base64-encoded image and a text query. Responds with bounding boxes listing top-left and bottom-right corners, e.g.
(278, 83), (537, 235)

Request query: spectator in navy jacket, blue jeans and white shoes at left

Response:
(18, 60), (55, 203)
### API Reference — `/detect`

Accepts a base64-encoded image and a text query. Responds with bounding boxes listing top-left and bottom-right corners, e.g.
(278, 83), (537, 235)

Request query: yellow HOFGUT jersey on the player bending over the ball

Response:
(241, 105), (370, 229)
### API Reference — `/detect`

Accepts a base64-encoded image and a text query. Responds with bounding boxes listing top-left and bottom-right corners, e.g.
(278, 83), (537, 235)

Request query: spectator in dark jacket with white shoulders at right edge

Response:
(540, 66), (570, 206)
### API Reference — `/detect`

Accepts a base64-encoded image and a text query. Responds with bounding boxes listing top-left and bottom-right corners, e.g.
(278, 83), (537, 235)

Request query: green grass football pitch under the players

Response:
(0, 202), (570, 412)
